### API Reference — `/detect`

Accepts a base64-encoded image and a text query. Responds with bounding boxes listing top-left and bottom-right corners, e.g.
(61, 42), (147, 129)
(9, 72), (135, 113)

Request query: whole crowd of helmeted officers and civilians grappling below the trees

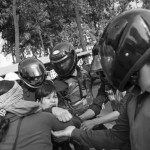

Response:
(0, 9), (150, 150)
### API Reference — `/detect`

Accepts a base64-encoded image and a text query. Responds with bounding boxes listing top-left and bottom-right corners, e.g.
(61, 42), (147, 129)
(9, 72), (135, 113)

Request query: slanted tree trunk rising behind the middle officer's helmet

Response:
(74, 0), (86, 51)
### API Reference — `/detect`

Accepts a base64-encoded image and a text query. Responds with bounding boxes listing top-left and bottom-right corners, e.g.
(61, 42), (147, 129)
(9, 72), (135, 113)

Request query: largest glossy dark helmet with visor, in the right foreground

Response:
(99, 9), (150, 91)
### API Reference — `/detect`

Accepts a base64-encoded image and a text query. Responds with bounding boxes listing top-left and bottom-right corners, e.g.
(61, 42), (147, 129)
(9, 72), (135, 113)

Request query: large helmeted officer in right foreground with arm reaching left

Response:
(53, 9), (150, 150)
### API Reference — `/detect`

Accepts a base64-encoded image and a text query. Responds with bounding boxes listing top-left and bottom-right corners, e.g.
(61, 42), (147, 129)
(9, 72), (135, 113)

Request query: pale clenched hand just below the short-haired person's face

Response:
(52, 107), (72, 122)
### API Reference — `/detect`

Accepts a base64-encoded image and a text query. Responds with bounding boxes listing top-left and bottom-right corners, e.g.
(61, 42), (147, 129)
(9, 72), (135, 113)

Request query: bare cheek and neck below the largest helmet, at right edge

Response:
(138, 63), (150, 92)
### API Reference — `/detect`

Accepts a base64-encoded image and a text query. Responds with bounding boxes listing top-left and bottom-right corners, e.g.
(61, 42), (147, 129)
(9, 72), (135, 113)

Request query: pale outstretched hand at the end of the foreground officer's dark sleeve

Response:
(51, 126), (75, 137)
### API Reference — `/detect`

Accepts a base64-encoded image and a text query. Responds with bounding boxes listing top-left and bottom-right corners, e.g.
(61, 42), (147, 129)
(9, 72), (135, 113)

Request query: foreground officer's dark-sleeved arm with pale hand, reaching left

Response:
(53, 94), (130, 149)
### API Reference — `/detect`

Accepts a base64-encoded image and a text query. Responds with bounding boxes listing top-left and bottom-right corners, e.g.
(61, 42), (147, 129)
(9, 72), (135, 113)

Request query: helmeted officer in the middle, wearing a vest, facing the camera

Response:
(50, 42), (100, 121)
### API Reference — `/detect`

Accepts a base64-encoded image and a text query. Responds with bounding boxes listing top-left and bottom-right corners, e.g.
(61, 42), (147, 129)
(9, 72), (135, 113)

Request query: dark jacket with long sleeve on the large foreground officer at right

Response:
(72, 93), (150, 150)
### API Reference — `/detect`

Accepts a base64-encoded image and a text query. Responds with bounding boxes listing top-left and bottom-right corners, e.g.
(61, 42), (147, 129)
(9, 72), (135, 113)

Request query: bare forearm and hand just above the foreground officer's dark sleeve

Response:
(81, 111), (120, 130)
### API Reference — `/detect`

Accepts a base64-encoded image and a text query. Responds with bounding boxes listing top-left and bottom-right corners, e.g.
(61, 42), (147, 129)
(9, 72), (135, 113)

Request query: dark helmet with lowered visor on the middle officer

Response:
(50, 42), (77, 77)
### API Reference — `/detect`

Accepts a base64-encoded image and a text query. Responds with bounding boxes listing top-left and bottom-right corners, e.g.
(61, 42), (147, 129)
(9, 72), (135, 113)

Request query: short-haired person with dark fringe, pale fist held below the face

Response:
(35, 80), (81, 128)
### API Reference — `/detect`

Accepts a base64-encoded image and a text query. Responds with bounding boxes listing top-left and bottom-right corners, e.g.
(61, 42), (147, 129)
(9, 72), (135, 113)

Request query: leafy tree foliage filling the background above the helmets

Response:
(0, 0), (146, 61)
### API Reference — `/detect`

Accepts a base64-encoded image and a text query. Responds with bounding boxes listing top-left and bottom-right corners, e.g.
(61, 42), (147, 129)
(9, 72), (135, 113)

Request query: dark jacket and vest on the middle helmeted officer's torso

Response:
(54, 67), (101, 115)
